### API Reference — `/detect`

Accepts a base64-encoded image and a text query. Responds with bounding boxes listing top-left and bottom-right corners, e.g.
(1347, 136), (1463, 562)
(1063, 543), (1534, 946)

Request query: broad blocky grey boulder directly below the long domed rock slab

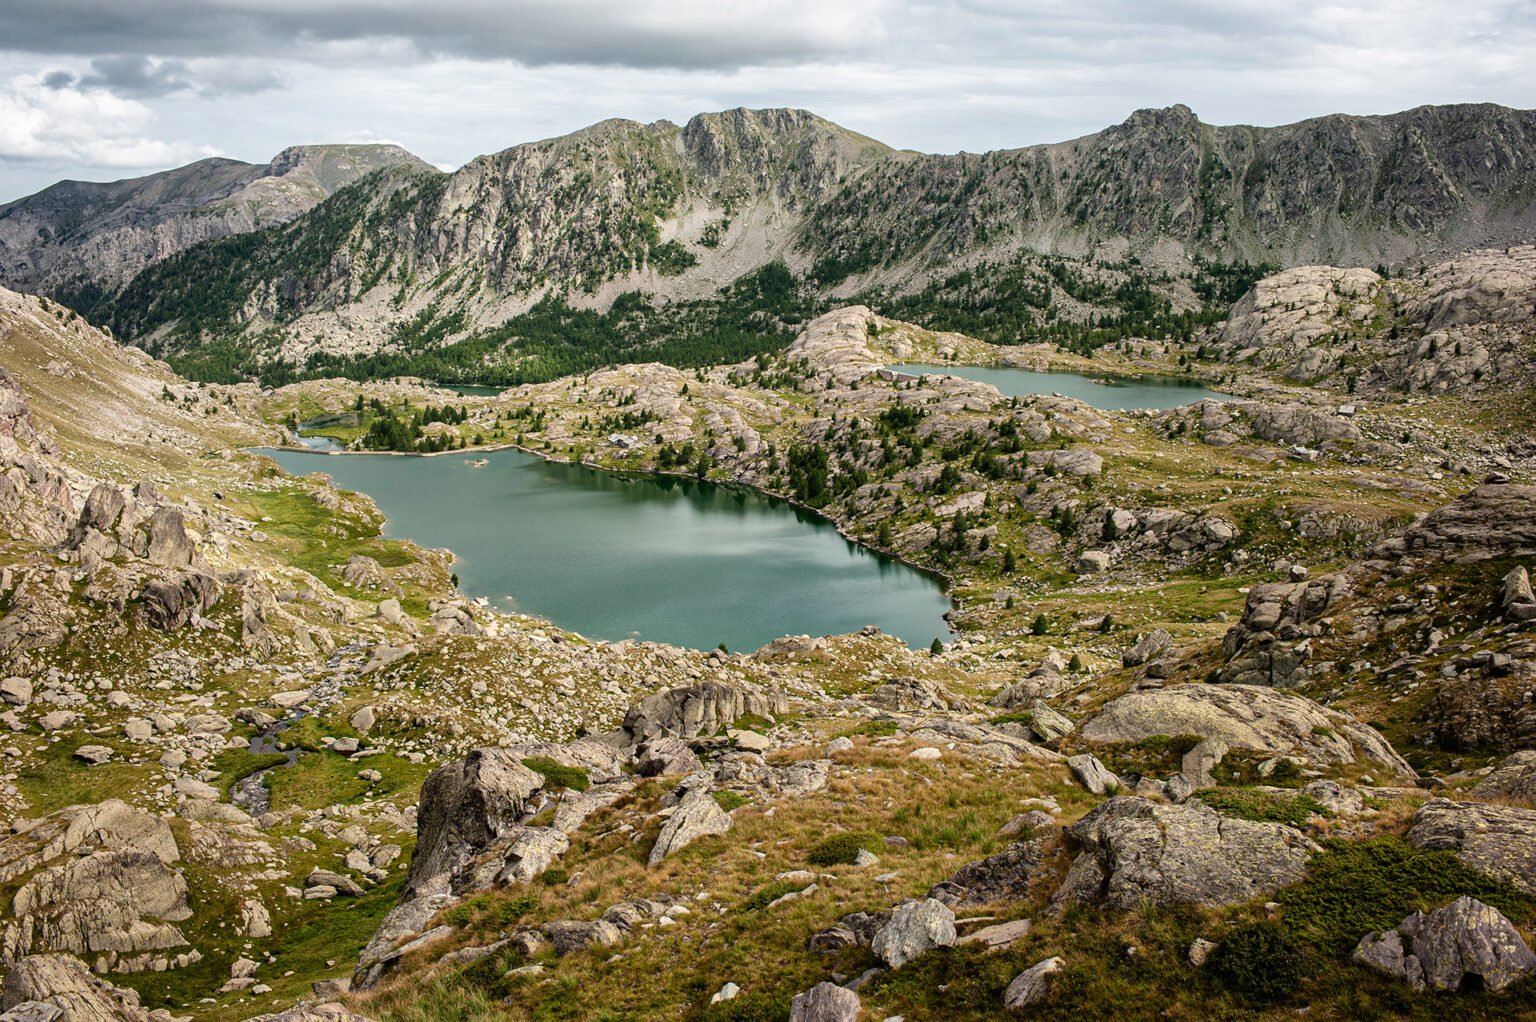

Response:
(1054, 796), (1316, 910)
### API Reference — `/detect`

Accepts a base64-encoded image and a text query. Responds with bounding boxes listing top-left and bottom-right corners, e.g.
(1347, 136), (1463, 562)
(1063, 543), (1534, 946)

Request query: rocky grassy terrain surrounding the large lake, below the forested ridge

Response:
(0, 251), (1536, 1022)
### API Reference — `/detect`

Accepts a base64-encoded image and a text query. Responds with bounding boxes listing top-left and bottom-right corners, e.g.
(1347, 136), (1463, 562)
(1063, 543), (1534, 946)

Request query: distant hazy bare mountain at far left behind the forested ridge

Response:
(0, 146), (427, 292)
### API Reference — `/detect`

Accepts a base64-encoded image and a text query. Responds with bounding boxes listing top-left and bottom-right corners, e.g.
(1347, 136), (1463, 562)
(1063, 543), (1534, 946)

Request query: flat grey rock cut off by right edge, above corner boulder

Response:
(1409, 799), (1536, 894)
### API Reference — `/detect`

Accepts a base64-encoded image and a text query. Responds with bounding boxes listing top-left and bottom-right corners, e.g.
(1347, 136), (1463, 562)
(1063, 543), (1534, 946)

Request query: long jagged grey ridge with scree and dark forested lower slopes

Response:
(29, 105), (1536, 384)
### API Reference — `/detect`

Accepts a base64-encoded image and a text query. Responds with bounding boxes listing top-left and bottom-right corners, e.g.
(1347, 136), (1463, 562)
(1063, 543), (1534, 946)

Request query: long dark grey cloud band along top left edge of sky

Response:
(5, 0), (892, 68)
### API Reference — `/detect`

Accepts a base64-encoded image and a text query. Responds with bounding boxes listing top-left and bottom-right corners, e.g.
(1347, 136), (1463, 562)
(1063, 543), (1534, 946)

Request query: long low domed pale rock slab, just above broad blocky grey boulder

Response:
(1081, 684), (1415, 778)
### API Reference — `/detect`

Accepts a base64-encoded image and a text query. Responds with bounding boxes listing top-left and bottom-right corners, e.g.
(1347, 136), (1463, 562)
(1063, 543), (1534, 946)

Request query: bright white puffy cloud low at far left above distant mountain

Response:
(0, 75), (217, 171)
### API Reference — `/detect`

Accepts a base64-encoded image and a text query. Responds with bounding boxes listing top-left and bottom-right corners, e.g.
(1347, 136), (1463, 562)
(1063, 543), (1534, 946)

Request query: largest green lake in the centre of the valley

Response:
(264, 450), (949, 650)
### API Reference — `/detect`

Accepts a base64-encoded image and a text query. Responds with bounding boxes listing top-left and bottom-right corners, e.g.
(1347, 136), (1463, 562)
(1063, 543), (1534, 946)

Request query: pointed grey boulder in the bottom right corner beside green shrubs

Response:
(1353, 898), (1536, 990)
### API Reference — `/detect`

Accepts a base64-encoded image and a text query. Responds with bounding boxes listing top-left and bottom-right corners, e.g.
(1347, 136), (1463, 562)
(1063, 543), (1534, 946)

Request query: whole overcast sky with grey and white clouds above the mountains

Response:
(0, 0), (1536, 201)
